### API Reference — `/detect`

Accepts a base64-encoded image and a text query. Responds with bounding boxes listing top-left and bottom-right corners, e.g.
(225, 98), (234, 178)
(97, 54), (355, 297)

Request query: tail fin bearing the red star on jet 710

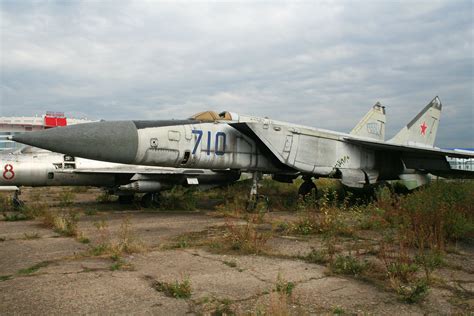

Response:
(389, 97), (442, 147)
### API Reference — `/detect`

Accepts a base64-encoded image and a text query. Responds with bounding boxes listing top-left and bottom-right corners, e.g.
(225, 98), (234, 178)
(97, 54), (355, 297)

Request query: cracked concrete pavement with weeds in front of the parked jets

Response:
(0, 188), (474, 315)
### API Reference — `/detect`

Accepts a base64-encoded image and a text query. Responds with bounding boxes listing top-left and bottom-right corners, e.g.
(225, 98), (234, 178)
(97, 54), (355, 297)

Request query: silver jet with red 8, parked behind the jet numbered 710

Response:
(0, 147), (240, 207)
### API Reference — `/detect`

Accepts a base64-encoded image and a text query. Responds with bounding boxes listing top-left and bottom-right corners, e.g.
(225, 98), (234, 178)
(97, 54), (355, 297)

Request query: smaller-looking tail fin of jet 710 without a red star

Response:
(350, 102), (385, 141)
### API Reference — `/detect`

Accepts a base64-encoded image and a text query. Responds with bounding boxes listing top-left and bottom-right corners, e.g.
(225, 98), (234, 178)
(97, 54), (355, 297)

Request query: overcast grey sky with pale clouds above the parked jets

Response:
(0, 0), (474, 147)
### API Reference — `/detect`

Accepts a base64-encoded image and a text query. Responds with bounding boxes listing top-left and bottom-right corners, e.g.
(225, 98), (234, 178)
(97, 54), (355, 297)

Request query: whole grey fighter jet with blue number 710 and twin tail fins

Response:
(14, 97), (472, 200)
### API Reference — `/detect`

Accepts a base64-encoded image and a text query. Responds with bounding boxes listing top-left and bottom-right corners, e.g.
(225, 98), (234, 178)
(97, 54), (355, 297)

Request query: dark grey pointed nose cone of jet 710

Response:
(13, 121), (138, 163)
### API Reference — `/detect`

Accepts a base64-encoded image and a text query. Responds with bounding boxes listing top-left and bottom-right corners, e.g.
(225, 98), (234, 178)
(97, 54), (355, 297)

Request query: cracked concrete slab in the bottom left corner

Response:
(0, 271), (188, 315)
